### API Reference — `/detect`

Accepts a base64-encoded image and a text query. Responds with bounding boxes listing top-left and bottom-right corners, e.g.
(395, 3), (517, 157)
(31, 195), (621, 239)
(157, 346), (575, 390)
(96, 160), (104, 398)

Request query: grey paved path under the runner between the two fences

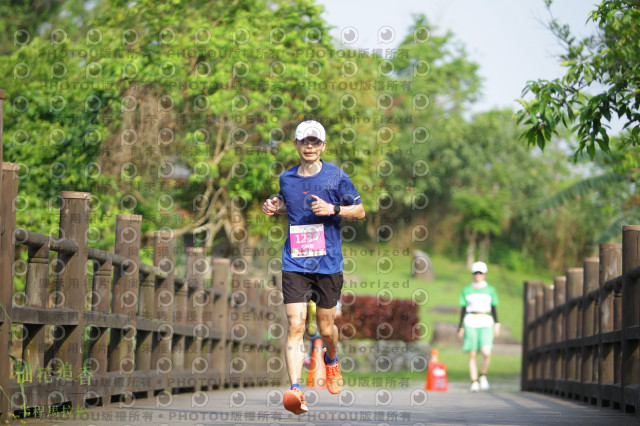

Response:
(22, 383), (640, 426)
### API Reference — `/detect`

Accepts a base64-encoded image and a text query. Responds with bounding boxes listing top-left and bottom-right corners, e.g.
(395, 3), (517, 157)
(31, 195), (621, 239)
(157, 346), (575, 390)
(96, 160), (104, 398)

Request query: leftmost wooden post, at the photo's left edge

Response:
(0, 161), (18, 420)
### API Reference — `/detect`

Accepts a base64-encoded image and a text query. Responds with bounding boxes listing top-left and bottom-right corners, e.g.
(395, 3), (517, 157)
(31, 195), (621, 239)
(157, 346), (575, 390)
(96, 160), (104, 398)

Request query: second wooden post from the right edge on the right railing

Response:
(598, 244), (622, 407)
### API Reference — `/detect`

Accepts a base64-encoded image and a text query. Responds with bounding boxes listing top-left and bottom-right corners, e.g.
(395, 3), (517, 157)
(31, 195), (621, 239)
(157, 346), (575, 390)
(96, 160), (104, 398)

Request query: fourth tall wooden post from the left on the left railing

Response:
(151, 231), (176, 392)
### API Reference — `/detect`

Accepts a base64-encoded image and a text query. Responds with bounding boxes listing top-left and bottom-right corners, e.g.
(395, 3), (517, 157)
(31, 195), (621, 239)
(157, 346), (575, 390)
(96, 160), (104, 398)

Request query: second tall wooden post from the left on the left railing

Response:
(56, 191), (91, 409)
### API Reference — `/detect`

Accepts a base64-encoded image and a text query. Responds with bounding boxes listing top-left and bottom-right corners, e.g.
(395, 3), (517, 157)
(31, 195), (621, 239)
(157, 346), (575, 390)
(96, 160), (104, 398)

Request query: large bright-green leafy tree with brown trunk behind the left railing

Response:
(0, 0), (394, 257)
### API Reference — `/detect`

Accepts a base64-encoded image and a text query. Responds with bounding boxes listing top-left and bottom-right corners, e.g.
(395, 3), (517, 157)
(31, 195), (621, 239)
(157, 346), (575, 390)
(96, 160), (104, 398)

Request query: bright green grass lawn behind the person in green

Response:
(330, 244), (545, 388)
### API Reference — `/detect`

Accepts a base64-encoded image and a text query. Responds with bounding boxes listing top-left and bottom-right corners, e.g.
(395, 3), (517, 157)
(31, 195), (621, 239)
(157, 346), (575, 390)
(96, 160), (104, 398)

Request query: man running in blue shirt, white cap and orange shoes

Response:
(262, 120), (365, 414)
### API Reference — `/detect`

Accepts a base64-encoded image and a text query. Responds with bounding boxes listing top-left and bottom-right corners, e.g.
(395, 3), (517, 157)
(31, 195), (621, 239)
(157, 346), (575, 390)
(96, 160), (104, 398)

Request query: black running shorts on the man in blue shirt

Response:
(282, 271), (344, 309)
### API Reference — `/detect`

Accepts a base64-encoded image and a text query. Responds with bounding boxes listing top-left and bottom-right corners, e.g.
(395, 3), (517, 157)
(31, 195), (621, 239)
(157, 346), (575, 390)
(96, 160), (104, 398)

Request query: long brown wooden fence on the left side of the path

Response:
(0, 92), (285, 418)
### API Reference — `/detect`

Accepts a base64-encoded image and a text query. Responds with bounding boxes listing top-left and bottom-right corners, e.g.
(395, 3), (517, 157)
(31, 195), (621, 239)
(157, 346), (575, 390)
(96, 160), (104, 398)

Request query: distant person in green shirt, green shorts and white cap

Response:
(458, 262), (500, 392)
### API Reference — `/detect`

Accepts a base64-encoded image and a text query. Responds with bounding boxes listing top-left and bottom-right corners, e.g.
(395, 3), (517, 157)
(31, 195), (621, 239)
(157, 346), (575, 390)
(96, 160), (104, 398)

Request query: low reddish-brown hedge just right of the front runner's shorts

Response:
(336, 295), (418, 342)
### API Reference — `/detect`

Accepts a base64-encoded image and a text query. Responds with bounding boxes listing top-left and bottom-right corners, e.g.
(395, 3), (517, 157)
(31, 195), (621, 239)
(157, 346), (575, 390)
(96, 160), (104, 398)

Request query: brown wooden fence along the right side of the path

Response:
(521, 226), (640, 414)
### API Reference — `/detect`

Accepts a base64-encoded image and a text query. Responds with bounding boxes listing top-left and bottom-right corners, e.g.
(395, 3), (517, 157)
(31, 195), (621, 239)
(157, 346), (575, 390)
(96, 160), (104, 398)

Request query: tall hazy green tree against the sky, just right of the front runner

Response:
(380, 15), (481, 240)
